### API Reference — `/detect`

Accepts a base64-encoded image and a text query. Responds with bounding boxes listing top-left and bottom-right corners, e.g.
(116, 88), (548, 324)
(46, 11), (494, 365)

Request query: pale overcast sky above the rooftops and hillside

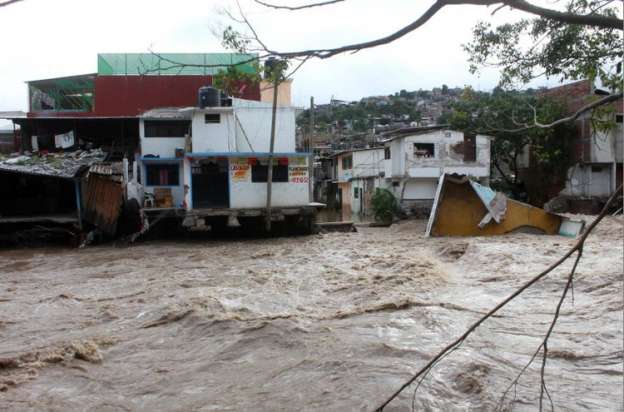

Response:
(0, 0), (560, 127)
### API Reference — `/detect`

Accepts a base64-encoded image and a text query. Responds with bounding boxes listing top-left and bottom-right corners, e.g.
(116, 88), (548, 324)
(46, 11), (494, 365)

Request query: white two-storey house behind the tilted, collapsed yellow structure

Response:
(334, 126), (491, 215)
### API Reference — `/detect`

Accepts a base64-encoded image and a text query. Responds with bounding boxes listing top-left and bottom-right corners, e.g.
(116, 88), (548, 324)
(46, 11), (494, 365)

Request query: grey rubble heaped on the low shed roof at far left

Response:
(0, 149), (106, 177)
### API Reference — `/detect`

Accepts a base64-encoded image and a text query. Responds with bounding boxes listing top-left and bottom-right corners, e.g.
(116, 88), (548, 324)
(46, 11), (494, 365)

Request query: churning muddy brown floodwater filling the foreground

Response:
(0, 217), (624, 411)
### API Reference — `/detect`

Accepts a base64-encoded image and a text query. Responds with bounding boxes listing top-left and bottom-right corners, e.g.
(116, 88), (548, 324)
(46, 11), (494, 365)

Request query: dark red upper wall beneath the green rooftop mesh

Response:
(93, 76), (260, 116)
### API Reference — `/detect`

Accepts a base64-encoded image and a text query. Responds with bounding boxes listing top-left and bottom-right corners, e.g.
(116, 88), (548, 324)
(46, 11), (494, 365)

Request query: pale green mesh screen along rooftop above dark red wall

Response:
(98, 53), (257, 76)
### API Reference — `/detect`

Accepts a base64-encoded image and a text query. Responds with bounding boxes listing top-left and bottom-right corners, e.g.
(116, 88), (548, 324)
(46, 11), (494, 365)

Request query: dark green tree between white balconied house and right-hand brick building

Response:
(449, 88), (574, 206)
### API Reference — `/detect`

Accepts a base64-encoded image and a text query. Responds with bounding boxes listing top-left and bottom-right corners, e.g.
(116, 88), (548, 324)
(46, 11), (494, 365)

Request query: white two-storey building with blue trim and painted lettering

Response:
(139, 98), (311, 227)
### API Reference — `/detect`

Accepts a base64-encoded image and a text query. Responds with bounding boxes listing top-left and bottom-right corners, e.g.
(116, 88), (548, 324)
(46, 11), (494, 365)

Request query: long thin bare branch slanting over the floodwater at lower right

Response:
(377, 185), (622, 411)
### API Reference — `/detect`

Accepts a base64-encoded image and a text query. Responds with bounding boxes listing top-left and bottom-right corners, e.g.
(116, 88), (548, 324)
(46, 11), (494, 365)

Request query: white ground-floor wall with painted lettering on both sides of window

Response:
(229, 157), (311, 209)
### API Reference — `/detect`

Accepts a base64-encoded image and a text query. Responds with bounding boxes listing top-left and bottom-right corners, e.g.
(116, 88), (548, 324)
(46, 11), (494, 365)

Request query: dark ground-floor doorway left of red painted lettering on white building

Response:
(191, 157), (230, 209)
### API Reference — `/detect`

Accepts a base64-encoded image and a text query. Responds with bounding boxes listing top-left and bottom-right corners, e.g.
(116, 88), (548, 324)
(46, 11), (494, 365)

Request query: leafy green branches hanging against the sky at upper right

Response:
(464, 0), (623, 91)
